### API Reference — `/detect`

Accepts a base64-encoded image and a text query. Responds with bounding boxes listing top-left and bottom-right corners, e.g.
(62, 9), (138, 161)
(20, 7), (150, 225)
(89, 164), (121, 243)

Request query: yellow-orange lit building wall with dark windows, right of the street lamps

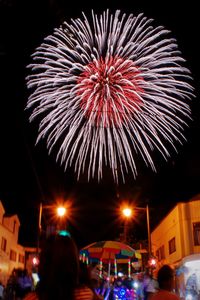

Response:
(151, 197), (200, 267)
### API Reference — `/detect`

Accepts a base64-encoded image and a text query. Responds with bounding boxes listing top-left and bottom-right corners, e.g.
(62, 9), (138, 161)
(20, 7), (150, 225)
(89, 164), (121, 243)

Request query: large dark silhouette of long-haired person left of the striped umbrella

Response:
(24, 234), (79, 300)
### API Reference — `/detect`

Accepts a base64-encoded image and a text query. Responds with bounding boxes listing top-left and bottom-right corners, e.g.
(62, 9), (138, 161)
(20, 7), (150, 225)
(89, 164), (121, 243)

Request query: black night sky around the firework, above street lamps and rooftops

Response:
(0, 0), (200, 246)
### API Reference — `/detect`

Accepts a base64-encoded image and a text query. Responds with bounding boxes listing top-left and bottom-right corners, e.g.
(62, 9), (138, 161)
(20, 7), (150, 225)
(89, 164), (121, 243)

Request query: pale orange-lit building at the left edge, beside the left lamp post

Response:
(0, 201), (25, 284)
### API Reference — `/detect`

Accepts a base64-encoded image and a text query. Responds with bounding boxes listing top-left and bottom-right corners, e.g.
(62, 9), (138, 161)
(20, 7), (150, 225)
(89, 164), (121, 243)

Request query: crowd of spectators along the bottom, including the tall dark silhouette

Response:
(0, 234), (179, 300)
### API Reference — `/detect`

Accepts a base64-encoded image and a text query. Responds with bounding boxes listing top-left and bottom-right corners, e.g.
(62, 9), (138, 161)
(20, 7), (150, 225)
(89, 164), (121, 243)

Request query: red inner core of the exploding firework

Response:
(77, 57), (143, 127)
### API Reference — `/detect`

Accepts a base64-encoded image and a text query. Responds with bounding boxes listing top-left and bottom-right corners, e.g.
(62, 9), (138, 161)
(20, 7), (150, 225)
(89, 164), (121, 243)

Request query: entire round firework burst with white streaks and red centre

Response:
(27, 10), (193, 182)
